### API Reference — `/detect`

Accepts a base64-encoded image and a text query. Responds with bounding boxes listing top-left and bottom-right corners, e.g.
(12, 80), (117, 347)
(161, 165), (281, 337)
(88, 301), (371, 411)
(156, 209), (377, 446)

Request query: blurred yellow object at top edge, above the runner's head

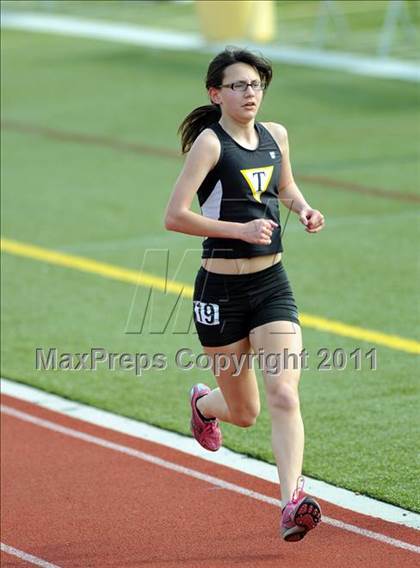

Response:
(195, 0), (275, 42)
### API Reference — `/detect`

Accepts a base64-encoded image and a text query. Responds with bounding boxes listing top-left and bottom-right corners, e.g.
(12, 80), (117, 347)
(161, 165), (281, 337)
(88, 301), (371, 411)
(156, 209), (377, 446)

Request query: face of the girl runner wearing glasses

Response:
(209, 63), (263, 122)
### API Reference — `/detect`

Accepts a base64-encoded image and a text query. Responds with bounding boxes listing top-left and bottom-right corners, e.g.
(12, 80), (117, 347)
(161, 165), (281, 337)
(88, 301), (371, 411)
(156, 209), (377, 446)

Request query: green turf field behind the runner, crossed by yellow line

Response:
(2, 4), (420, 511)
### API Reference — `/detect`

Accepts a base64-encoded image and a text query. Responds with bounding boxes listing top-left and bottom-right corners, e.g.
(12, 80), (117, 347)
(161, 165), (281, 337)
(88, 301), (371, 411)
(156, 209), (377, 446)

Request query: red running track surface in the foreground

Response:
(1, 396), (420, 568)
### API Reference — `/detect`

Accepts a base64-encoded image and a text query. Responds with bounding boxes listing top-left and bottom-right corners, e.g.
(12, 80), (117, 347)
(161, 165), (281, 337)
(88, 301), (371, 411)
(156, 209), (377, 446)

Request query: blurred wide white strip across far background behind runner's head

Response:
(1, 10), (420, 82)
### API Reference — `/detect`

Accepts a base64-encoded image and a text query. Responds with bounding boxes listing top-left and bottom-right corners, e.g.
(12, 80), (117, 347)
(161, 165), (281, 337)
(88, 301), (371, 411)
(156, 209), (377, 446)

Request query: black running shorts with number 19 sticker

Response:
(193, 261), (299, 347)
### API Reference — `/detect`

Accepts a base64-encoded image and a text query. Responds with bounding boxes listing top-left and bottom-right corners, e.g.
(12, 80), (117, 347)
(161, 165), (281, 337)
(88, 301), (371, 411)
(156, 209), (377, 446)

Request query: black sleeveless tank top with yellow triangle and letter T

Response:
(197, 123), (283, 258)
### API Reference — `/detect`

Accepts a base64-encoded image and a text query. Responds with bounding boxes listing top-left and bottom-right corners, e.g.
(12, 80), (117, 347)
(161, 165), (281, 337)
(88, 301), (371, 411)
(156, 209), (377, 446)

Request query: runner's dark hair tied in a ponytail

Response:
(178, 48), (273, 154)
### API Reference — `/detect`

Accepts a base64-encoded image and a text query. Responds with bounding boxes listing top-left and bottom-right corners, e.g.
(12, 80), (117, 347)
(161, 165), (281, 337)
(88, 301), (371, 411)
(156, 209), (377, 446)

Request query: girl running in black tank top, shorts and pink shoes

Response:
(165, 49), (324, 541)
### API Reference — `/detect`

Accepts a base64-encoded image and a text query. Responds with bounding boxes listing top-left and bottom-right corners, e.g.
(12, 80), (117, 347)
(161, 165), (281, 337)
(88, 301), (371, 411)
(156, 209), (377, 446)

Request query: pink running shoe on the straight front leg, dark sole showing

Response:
(280, 476), (321, 542)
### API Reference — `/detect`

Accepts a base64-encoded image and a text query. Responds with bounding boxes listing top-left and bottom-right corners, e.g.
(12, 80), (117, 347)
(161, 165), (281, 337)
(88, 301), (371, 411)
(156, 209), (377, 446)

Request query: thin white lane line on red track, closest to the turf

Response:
(1, 405), (420, 554)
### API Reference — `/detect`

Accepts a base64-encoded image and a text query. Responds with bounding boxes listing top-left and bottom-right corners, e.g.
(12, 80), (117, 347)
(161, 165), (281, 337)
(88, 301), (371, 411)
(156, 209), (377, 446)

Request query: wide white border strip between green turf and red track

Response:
(1, 379), (420, 529)
